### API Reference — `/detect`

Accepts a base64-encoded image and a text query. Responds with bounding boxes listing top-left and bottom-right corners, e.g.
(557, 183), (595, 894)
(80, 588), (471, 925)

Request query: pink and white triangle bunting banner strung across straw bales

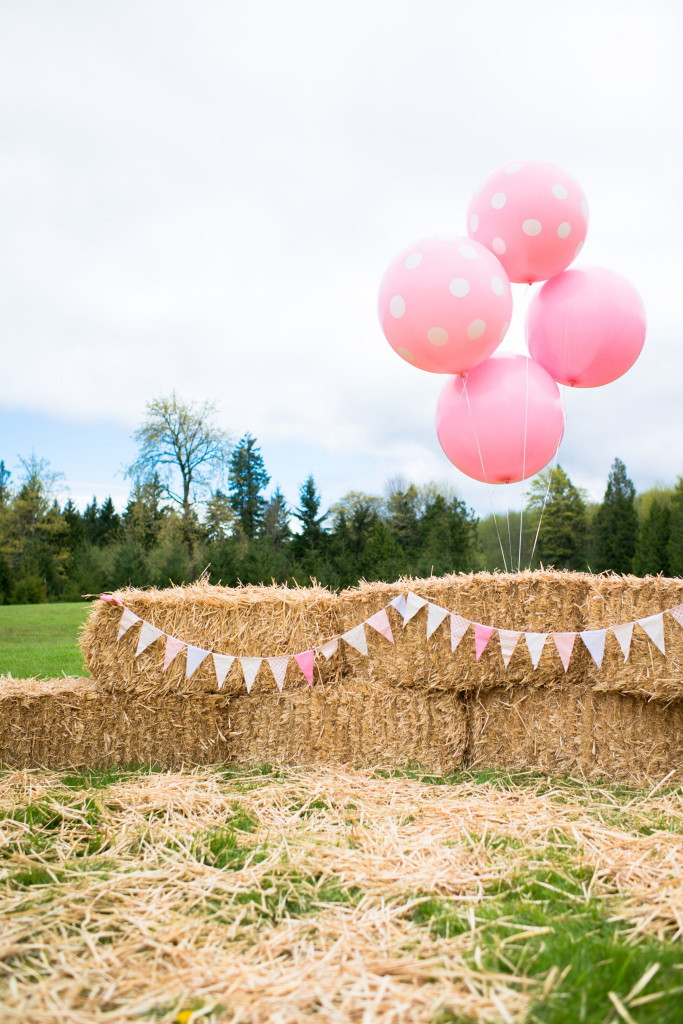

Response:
(108, 591), (683, 693)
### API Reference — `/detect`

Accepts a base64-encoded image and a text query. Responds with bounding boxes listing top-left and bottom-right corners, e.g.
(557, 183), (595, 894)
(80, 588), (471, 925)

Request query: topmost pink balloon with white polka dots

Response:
(467, 160), (588, 283)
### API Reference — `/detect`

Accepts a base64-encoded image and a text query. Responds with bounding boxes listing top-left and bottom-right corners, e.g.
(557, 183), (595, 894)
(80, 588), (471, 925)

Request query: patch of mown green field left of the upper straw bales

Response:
(0, 601), (90, 679)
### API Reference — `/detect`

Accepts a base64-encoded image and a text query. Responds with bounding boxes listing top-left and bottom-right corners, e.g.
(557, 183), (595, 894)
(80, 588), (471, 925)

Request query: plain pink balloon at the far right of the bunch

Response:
(526, 267), (645, 387)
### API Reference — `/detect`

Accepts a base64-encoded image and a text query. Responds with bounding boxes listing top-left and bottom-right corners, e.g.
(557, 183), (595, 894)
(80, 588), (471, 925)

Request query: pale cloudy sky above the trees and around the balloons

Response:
(0, 0), (683, 514)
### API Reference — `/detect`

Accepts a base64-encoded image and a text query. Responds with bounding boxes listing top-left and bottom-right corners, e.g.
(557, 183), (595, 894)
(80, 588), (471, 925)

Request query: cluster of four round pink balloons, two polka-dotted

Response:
(379, 160), (645, 483)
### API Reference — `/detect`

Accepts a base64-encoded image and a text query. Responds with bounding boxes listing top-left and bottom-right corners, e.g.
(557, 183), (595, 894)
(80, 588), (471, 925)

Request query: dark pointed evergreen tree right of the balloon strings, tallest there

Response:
(594, 459), (638, 572)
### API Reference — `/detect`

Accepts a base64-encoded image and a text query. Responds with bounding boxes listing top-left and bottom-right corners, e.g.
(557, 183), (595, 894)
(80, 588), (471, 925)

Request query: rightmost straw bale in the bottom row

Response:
(466, 684), (683, 783)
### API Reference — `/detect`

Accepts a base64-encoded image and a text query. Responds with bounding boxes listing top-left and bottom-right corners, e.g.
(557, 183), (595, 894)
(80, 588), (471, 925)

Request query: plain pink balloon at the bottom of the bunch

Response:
(436, 354), (564, 483)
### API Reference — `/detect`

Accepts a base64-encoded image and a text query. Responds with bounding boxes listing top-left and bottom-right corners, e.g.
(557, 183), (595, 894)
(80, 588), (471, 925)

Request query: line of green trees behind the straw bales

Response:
(0, 394), (683, 603)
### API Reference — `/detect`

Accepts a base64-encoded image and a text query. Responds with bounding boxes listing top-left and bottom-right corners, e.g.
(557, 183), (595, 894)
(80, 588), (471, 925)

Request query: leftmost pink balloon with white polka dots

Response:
(379, 237), (512, 374)
